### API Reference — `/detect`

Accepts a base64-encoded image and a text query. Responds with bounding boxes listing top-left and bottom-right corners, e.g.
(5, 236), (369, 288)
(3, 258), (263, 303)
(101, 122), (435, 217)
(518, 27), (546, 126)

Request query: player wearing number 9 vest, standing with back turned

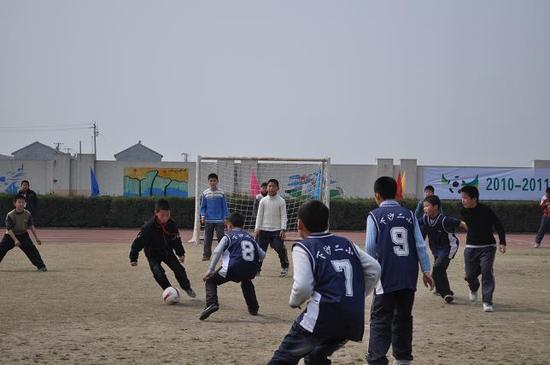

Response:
(366, 176), (434, 365)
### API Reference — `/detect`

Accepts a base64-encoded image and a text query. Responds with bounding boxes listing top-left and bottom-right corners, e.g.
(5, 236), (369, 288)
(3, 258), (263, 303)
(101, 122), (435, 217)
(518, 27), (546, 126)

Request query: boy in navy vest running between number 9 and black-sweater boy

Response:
(420, 195), (466, 303)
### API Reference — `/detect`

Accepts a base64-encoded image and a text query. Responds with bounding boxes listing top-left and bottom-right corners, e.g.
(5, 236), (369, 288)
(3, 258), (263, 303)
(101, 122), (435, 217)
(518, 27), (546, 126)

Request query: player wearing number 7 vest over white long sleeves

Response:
(269, 200), (380, 364)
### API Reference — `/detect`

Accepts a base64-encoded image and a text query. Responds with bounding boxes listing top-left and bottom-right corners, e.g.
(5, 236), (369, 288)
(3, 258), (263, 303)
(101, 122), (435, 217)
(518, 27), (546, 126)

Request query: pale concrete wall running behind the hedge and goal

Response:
(0, 154), (550, 198)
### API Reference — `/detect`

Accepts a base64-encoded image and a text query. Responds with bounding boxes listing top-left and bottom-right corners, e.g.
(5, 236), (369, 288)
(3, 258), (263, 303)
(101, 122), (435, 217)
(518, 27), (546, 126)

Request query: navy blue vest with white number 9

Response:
(369, 201), (418, 294)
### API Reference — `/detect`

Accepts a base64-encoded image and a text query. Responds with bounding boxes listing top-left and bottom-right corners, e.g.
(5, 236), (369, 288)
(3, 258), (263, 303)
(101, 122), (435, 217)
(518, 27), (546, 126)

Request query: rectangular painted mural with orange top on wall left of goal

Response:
(124, 167), (189, 198)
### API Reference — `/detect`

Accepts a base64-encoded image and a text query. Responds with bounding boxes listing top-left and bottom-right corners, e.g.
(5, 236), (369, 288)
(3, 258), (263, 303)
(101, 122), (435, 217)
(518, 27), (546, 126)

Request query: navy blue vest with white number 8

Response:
(222, 229), (260, 281)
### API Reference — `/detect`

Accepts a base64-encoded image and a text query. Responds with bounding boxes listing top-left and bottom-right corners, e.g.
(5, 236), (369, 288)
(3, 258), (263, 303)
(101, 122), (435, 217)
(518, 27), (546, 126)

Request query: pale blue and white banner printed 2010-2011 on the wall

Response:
(424, 167), (550, 201)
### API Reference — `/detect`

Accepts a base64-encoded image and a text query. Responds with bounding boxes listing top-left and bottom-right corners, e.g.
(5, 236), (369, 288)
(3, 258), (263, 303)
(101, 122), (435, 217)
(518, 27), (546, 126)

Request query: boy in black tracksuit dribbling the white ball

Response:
(130, 199), (196, 298)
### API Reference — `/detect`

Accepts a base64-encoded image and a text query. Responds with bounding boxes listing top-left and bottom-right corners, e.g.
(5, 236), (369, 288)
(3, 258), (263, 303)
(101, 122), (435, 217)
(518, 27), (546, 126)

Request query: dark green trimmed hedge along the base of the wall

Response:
(0, 195), (541, 232)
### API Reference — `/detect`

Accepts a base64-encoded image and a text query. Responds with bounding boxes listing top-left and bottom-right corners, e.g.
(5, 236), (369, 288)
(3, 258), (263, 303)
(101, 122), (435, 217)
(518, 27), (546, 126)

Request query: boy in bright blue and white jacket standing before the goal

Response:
(200, 173), (229, 261)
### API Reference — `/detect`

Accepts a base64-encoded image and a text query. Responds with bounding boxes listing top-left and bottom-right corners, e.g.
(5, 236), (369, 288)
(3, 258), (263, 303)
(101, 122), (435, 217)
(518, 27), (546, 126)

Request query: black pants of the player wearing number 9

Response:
(367, 290), (414, 365)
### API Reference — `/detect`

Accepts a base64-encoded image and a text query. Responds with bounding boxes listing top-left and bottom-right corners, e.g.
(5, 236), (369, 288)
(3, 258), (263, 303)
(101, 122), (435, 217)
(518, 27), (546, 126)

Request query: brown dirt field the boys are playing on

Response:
(0, 229), (550, 364)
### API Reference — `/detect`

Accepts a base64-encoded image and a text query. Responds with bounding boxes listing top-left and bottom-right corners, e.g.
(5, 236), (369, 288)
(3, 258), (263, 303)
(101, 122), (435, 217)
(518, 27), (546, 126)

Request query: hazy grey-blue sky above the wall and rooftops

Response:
(0, 0), (550, 166)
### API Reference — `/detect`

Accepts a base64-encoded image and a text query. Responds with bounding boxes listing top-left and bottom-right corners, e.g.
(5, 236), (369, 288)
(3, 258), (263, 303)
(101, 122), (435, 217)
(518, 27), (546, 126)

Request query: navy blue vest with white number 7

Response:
(294, 233), (365, 341)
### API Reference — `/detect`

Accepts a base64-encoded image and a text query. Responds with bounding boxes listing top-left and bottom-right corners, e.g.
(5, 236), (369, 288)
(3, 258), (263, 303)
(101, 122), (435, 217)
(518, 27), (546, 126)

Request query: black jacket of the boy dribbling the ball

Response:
(130, 217), (185, 261)
